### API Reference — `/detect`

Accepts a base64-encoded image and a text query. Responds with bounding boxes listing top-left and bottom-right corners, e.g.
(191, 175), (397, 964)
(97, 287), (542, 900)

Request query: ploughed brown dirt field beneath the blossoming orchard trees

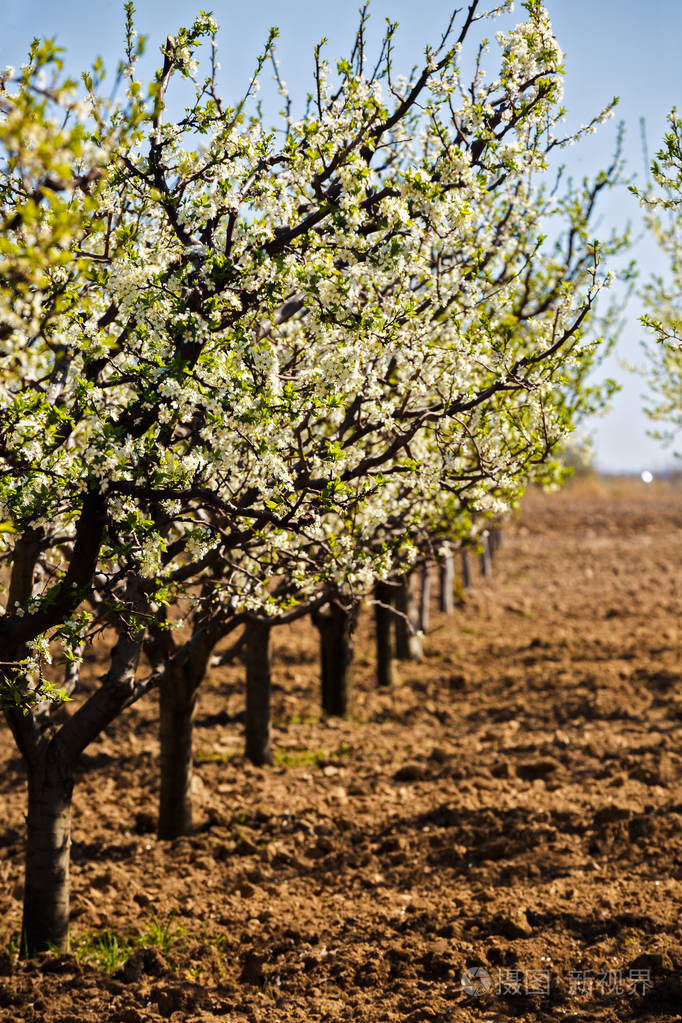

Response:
(0, 481), (682, 1023)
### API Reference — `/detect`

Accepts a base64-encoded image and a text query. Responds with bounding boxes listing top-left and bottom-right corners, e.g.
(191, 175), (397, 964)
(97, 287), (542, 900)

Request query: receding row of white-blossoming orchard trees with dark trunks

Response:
(0, 0), (621, 954)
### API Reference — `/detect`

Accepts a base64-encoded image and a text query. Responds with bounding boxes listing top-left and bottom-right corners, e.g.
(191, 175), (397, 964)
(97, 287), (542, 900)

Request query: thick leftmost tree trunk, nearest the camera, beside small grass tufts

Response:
(20, 746), (74, 958)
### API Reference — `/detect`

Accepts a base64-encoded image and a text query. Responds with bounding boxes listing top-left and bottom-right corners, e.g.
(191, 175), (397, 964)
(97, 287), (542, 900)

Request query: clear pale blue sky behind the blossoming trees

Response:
(0, 0), (682, 472)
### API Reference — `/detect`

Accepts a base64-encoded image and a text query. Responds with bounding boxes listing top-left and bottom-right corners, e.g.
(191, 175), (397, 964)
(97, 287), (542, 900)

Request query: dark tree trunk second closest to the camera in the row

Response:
(158, 670), (200, 839)
